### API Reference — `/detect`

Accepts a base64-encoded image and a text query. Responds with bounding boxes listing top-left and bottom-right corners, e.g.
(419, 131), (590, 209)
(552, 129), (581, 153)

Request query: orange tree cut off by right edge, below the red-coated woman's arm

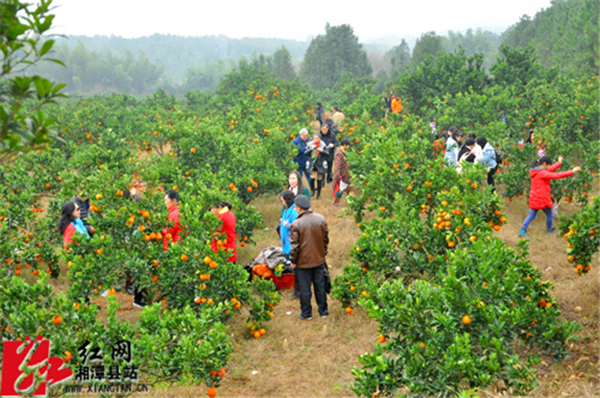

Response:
(559, 196), (600, 275)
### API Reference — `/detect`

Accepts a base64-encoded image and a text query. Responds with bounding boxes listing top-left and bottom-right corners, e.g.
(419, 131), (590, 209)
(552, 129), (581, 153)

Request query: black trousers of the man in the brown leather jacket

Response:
(296, 264), (329, 318)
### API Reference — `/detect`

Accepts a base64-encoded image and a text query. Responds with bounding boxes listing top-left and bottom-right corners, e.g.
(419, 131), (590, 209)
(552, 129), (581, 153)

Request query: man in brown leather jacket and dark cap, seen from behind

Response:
(290, 195), (329, 321)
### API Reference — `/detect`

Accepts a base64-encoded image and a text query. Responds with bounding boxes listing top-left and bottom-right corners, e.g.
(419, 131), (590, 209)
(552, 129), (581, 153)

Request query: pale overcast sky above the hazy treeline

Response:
(53, 0), (550, 43)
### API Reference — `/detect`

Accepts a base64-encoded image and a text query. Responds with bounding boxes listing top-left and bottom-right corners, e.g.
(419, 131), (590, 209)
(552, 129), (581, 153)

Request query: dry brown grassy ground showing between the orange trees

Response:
(45, 179), (600, 397)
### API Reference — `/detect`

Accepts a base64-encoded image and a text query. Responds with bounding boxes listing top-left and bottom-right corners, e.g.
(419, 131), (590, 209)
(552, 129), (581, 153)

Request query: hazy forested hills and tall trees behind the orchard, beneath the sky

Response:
(29, 0), (600, 96)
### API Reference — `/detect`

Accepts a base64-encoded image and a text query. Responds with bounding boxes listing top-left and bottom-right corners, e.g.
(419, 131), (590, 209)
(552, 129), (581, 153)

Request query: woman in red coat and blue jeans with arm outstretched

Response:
(519, 156), (581, 238)
